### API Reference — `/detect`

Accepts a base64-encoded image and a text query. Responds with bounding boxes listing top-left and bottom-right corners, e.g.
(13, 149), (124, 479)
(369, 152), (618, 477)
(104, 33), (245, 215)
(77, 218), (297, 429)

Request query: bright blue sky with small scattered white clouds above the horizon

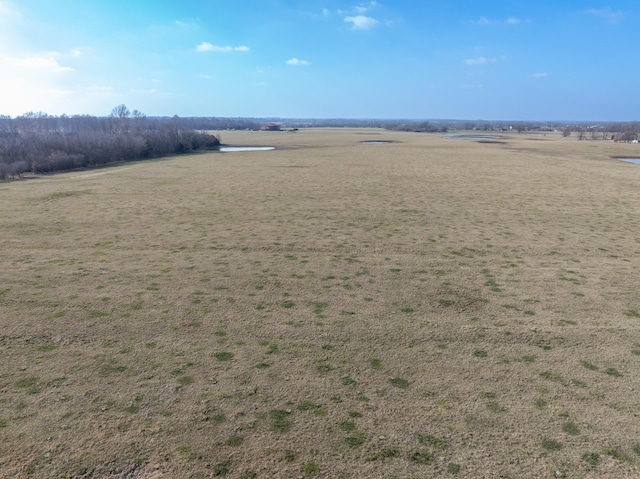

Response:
(0, 0), (640, 121)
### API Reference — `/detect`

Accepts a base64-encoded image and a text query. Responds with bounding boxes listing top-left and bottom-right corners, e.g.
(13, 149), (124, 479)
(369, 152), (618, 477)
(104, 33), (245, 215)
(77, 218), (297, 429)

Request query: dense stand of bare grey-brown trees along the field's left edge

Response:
(0, 105), (220, 180)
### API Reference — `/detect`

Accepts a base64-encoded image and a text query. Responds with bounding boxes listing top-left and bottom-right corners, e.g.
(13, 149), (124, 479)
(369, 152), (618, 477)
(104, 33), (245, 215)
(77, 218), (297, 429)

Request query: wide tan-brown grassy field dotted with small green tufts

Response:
(0, 129), (640, 479)
